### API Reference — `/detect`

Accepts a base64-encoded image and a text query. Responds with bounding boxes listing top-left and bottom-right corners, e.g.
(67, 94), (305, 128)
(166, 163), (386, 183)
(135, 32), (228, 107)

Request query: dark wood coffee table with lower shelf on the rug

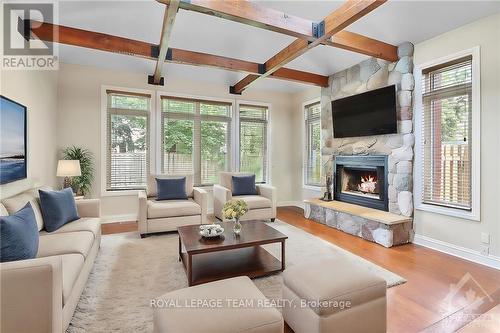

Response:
(177, 221), (288, 286)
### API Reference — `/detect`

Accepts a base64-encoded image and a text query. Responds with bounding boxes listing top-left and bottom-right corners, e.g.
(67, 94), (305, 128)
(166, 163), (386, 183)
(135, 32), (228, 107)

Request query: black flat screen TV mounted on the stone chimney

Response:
(332, 85), (398, 138)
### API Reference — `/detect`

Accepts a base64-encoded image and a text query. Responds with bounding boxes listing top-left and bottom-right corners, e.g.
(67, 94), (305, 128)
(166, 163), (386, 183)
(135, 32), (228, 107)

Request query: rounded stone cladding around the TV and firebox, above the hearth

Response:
(321, 42), (415, 216)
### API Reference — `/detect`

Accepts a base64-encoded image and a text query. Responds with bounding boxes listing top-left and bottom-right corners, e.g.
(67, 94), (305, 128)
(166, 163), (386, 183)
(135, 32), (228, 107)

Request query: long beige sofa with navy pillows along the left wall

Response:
(0, 188), (101, 333)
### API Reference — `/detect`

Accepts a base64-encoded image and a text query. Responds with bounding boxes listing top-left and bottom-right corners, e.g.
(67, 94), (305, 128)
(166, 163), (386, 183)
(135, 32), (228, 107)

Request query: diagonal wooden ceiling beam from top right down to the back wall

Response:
(230, 0), (386, 94)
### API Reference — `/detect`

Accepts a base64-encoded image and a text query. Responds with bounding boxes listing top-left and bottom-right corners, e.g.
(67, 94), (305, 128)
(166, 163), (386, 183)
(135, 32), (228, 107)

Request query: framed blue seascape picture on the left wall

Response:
(0, 96), (27, 184)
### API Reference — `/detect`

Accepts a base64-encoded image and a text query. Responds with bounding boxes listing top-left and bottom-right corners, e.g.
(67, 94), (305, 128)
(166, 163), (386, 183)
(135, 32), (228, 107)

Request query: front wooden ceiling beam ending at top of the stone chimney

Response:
(158, 0), (398, 61)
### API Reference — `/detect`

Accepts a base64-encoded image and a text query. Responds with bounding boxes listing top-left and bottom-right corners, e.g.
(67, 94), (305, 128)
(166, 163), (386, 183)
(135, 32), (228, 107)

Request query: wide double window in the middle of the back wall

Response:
(161, 97), (231, 185)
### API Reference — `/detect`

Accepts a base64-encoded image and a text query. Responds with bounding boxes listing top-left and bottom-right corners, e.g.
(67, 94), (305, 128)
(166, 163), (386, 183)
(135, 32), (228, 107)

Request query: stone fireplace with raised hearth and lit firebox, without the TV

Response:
(304, 42), (415, 247)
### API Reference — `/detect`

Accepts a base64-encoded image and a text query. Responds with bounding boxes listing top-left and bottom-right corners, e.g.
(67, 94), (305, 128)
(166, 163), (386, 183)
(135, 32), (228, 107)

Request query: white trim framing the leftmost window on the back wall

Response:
(99, 85), (156, 197)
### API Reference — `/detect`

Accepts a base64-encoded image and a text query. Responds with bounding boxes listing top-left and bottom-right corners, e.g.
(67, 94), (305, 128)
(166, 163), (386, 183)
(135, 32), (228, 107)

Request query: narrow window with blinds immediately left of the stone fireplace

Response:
(304, 101), (321, 186)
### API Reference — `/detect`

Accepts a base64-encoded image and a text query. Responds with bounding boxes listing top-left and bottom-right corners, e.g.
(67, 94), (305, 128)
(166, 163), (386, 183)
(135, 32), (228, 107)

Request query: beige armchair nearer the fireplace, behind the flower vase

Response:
(213, 172), (276, 221)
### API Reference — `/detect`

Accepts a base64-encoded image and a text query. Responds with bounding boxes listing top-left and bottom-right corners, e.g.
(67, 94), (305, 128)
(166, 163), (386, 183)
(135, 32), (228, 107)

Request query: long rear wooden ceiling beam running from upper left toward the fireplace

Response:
(22, 19), (328, 87)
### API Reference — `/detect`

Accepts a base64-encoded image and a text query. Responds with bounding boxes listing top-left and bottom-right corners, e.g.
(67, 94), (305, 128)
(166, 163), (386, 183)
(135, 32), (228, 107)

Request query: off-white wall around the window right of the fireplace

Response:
(414, 14), (500, 260)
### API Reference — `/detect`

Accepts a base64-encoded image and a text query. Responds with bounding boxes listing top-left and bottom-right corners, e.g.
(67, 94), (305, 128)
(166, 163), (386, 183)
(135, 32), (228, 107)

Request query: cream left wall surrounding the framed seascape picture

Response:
(0, 70), (58, 198)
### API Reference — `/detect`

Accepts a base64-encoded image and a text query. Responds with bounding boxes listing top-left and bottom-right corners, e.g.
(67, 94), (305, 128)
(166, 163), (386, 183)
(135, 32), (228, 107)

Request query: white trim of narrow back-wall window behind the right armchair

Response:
(233, 99), (273, 185)
